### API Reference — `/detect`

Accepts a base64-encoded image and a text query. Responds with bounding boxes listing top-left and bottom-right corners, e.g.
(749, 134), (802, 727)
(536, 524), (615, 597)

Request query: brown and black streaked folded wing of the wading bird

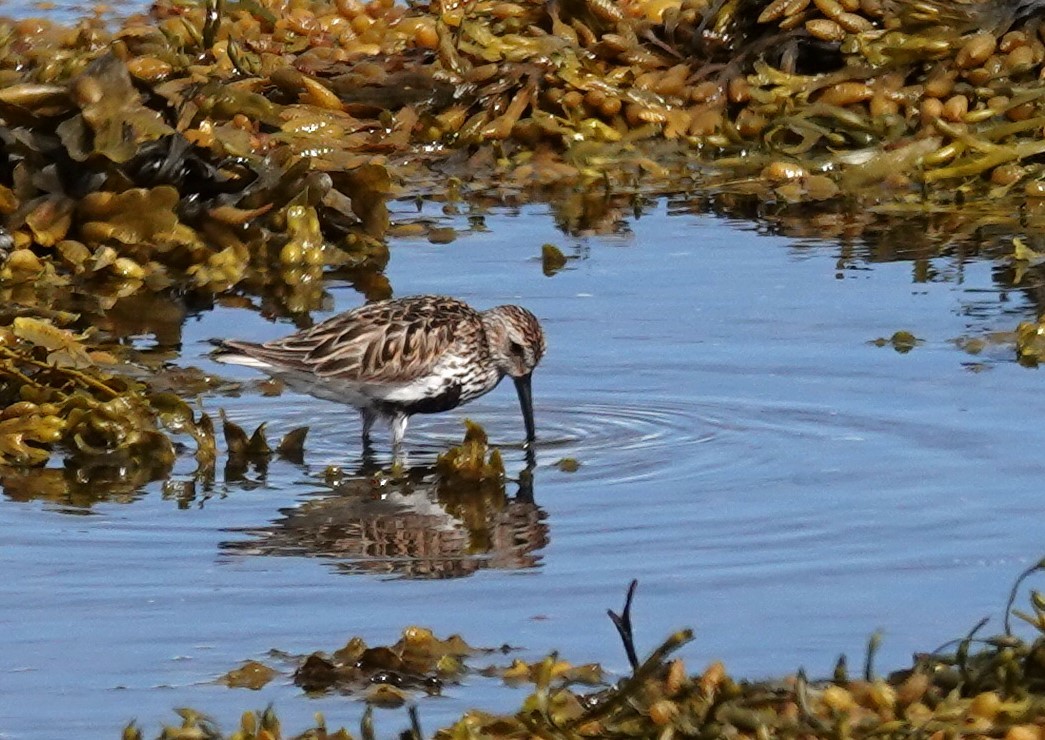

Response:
(234, 296), (482, 385)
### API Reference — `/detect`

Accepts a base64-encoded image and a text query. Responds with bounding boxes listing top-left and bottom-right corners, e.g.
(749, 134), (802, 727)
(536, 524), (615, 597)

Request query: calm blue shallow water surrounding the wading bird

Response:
(0, 193), (1045, 738)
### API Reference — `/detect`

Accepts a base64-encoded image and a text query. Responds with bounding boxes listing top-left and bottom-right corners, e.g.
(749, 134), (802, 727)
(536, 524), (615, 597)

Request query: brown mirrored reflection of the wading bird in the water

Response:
(222, 464), (549, 579)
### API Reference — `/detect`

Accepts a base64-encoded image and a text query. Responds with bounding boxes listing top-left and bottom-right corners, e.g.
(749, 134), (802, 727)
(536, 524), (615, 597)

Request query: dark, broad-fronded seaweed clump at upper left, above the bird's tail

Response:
(0, 44), (388, 313)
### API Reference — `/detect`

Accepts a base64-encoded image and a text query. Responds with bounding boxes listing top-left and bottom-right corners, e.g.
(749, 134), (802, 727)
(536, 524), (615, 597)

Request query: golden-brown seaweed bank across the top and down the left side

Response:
(6, 0), (1045, 480)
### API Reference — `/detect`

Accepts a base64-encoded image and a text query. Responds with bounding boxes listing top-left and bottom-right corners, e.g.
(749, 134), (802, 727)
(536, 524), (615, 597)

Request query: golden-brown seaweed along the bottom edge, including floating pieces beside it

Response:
(124, 560), (1045, 740)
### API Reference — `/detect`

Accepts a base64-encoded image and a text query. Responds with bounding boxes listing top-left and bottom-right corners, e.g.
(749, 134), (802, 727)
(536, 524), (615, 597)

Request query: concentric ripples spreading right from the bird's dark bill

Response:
(526, 398), (981, 483)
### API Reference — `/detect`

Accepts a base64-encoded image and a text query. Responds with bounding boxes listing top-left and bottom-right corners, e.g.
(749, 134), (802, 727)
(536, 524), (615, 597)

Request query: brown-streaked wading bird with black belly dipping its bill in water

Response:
(211, 295), (545, 454)
